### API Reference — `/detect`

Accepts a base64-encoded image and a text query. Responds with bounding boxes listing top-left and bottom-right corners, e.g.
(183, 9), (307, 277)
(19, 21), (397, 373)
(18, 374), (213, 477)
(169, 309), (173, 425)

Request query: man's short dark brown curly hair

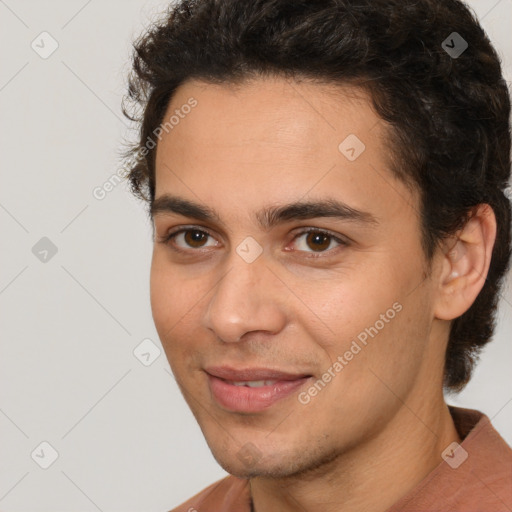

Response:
(123, 0), (511, 391)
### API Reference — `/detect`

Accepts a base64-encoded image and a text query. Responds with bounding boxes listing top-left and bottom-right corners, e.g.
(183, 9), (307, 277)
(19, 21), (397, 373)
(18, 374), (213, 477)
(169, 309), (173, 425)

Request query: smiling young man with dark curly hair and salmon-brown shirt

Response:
(122, 0), (512, 512)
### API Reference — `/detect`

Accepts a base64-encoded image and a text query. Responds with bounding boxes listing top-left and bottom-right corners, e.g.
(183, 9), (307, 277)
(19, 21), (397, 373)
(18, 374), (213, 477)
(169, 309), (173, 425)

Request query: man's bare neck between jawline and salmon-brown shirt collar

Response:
(249, 396), (461, 512)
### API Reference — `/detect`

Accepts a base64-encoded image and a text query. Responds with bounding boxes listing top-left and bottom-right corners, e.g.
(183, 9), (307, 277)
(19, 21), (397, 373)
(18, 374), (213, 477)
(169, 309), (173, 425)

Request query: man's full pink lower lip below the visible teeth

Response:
(208, 374), (311, 412)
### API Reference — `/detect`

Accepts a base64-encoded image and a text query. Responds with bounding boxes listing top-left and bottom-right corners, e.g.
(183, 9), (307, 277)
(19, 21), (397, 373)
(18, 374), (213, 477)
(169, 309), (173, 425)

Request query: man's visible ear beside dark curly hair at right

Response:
(434, 204), (496, 320)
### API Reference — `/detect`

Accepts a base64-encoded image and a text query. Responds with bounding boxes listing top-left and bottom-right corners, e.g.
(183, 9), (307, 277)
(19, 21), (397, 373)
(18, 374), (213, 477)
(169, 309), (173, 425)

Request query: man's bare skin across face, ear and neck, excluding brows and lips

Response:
(151, 77), (495, 512)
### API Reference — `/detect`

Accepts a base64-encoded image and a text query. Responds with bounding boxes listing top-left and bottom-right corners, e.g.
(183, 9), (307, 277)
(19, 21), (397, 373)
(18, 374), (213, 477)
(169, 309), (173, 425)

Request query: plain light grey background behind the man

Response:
(0, 0), (512, 512)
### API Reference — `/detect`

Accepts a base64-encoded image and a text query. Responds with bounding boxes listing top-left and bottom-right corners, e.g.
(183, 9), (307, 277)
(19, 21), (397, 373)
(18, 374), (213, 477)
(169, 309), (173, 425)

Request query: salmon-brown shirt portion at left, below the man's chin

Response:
(170, 475), (250, 512)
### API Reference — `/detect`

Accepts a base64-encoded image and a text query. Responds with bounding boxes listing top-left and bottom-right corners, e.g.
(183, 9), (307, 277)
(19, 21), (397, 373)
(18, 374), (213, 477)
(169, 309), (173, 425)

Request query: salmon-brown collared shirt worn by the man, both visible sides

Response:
(171, 406), (512, 512)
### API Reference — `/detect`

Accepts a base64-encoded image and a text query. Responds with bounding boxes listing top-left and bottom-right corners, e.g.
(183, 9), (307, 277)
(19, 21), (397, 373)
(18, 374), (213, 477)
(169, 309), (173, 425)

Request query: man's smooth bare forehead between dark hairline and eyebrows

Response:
(150, 77), (410, 222)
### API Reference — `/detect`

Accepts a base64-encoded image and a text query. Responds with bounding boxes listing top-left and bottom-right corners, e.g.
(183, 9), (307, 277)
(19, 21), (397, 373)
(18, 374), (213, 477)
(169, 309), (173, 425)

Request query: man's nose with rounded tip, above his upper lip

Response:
(203, 253), (286, 342)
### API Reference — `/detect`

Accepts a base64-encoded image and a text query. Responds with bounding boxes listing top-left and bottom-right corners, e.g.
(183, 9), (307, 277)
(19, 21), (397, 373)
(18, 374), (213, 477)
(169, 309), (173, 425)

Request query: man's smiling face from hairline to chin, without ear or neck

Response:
(151, 79), (442, 477)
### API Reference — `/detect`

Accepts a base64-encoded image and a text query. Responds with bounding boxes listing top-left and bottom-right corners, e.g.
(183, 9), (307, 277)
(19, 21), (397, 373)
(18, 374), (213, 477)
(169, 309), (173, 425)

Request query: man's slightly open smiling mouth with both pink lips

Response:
(205, 367), (313, 413)
